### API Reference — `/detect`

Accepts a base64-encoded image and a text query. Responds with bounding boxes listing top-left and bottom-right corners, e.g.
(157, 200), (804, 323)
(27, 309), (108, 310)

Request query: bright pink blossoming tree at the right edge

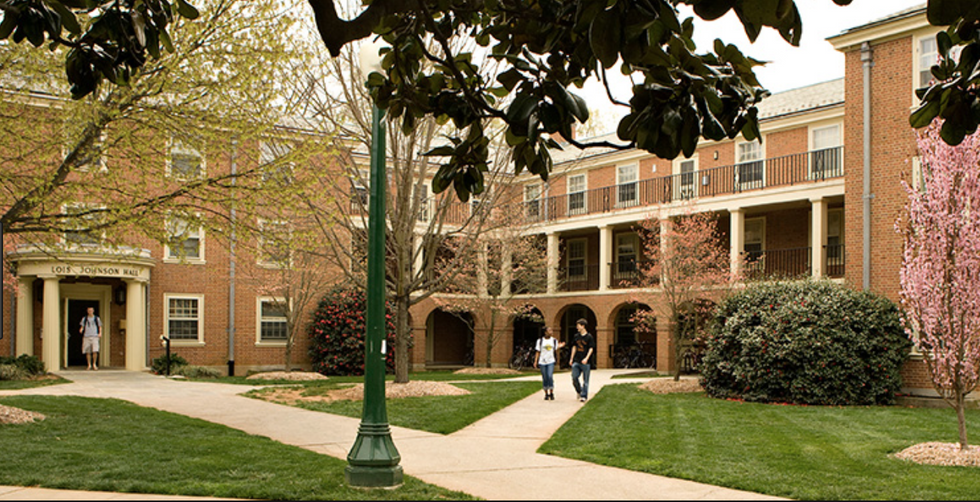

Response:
(897, 124), (980, 450)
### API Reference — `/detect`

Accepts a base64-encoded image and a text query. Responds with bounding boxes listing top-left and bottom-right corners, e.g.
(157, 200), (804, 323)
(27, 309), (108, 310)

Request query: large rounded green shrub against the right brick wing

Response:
(701, 281), (911, 405)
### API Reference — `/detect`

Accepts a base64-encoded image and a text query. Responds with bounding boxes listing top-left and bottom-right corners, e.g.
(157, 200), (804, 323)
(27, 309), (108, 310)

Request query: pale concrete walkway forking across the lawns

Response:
(0, 370), (774, 500)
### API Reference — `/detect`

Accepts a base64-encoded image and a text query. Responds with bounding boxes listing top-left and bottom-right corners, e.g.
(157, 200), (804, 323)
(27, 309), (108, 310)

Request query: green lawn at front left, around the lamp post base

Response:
(0, 396), (471, 500)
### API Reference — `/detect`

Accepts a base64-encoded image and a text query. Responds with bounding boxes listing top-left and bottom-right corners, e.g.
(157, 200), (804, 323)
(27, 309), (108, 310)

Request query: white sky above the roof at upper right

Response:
(582, 0), (925, 133)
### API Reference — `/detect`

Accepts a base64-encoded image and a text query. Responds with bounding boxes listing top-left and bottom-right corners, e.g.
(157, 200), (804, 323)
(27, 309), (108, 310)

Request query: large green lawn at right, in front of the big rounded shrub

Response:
(540, 385), (980, 500)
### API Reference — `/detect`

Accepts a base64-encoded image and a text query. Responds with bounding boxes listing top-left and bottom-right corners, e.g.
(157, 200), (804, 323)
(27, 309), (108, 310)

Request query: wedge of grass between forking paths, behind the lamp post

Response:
(253, 379), (541, 434)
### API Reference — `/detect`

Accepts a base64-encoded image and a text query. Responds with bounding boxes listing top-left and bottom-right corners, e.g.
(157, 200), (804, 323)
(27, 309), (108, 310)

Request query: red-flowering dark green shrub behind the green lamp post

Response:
(309, 288), (395, 375)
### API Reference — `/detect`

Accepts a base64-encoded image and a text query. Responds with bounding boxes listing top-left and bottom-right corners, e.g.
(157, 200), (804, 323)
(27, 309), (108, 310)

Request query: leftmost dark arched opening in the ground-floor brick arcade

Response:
(425, 309), (473, 366)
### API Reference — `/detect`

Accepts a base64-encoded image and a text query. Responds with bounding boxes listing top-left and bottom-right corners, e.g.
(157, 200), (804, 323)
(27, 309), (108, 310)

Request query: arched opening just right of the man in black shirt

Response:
(610, 303), (657, 368)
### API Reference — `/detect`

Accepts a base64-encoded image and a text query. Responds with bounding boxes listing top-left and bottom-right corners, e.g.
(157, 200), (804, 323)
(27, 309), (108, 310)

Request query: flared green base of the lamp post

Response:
(344, 422), (403, 488)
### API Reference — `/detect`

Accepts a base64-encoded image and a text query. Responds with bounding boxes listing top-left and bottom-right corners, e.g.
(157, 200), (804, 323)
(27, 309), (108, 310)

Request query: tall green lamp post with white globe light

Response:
(344, 43), (402, 488)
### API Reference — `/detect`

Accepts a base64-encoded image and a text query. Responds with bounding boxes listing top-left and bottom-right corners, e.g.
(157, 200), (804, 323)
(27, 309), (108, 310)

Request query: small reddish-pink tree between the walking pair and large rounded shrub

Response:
(634, 212), (736, 380)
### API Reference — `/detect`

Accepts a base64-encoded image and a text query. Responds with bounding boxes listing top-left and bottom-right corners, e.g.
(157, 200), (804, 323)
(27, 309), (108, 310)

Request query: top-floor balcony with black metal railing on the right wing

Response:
(524, 147), (844, 222)
